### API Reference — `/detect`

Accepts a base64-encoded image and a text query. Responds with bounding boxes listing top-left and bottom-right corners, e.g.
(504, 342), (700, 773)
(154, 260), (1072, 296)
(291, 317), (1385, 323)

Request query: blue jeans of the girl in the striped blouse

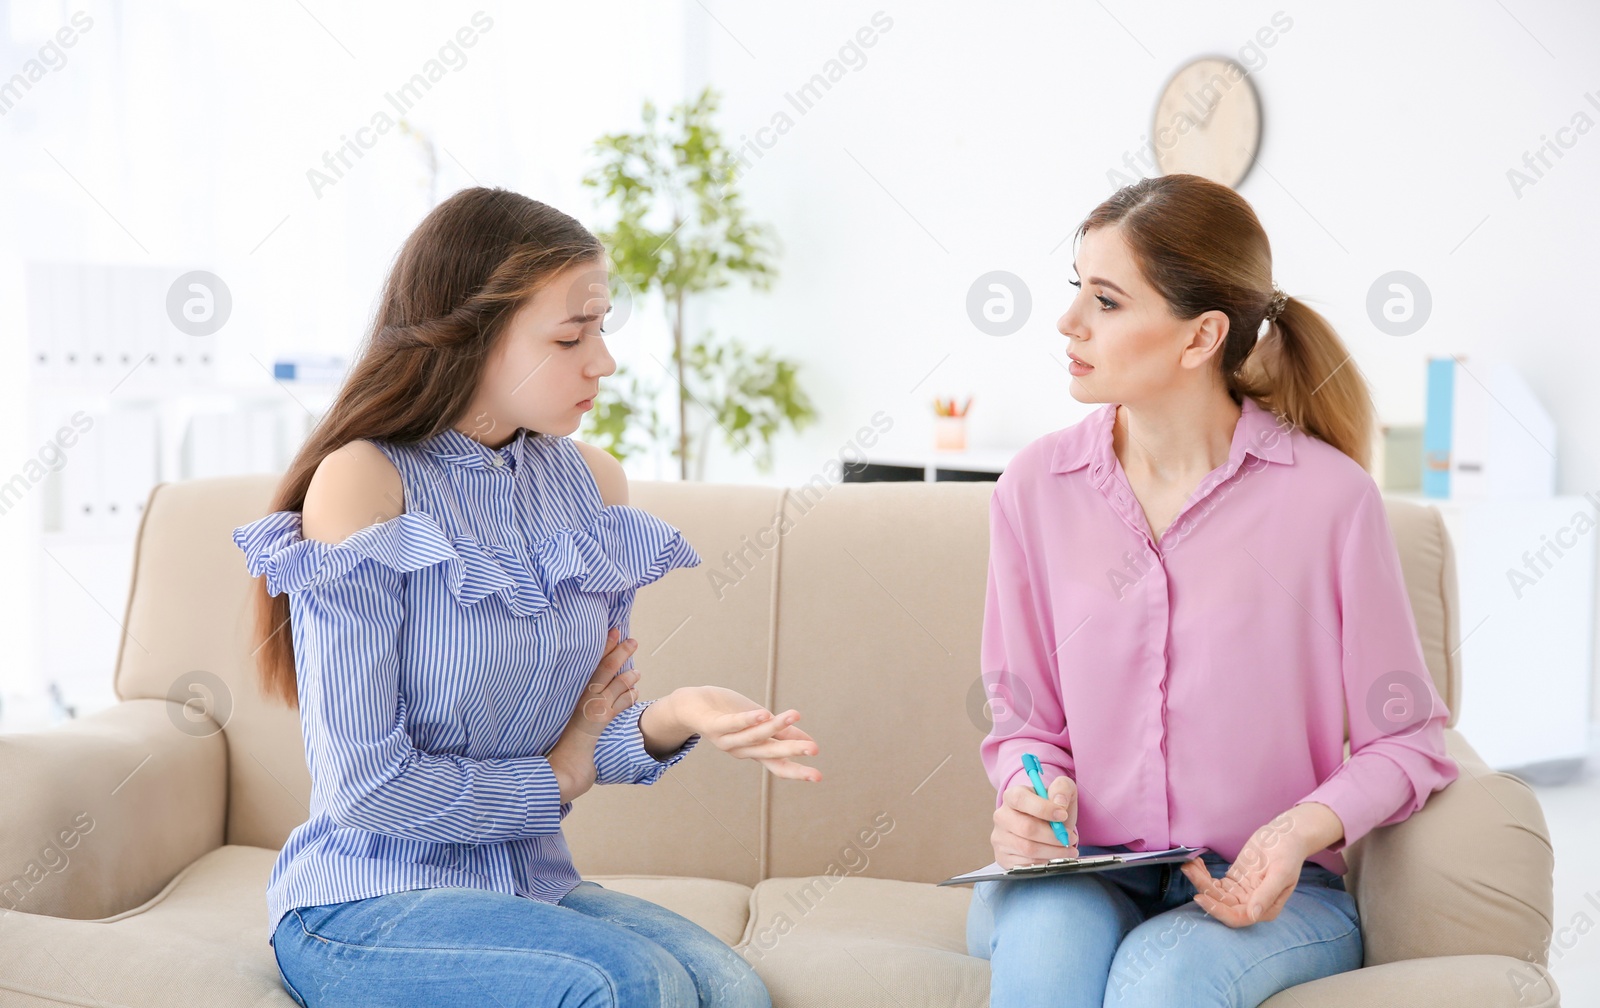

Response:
(272, 880), (773, 1008)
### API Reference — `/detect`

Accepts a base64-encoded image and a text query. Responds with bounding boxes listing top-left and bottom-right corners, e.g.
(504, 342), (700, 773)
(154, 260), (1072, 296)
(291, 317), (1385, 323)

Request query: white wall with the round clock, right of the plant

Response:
(675, 0), (1600, 720)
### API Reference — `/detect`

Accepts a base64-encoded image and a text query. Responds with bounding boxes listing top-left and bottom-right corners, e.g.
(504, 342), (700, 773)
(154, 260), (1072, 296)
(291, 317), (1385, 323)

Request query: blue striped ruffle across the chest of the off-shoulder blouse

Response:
(234, 504), (701, 616)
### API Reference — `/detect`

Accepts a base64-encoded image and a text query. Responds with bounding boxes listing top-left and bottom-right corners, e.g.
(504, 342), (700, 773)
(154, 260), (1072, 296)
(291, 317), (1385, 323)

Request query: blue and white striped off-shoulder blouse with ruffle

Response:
(234, 429), (699, 942)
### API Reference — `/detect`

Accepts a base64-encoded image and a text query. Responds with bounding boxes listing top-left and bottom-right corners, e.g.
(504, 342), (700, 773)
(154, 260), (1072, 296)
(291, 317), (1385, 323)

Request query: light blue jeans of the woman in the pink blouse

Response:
(966, 845), (1362, 1008)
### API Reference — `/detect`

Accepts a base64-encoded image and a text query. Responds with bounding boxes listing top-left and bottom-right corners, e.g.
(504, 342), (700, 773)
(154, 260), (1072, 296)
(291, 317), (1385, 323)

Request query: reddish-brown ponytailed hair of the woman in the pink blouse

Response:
(1077, 174), (1374, 469)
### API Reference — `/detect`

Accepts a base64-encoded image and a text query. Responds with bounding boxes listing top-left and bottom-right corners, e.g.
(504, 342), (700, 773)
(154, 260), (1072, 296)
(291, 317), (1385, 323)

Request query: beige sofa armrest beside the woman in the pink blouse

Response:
(1344, 728), (1555, 966)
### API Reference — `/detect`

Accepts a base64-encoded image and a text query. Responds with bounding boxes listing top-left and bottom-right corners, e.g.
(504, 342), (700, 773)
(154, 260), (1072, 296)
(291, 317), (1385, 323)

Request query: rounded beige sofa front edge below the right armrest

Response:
(1261, 953), (1562, 1008)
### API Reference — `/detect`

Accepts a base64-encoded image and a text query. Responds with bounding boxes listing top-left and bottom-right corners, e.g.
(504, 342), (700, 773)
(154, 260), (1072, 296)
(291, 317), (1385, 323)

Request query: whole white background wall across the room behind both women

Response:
(0, 0), (1600, 726)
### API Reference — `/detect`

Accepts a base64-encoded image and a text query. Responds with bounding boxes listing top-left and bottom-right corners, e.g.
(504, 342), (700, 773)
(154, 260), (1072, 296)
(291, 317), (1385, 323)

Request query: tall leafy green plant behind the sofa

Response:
(584, 88), (816, 480)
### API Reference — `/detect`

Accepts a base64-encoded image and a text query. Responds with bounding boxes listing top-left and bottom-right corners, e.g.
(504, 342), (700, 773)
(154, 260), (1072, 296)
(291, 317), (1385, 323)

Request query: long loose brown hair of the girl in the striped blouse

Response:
(254, 187), (605, 707)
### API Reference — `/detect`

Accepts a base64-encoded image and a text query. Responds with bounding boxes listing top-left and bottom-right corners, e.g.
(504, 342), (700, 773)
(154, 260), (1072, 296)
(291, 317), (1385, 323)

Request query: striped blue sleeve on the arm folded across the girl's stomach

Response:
(290, 558), (571, 843)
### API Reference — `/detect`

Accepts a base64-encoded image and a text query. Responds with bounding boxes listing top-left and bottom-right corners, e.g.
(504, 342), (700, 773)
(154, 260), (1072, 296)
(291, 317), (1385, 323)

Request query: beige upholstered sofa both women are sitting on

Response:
(0, 477), (1557, 1008)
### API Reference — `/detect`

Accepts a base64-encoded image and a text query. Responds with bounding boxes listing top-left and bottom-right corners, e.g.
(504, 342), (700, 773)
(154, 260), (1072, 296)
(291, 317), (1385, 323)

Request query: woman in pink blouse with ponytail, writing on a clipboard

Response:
(968, 174), (1458, 1008)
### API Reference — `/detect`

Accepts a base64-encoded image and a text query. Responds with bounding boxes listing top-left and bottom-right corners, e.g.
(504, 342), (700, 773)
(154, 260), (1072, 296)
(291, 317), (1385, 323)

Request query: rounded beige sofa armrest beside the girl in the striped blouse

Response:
(0, 699), (227, 920)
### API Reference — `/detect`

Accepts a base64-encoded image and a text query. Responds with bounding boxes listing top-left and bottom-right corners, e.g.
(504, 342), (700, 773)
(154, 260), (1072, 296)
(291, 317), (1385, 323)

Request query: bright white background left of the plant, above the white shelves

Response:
(0, 0), (685, 717)
